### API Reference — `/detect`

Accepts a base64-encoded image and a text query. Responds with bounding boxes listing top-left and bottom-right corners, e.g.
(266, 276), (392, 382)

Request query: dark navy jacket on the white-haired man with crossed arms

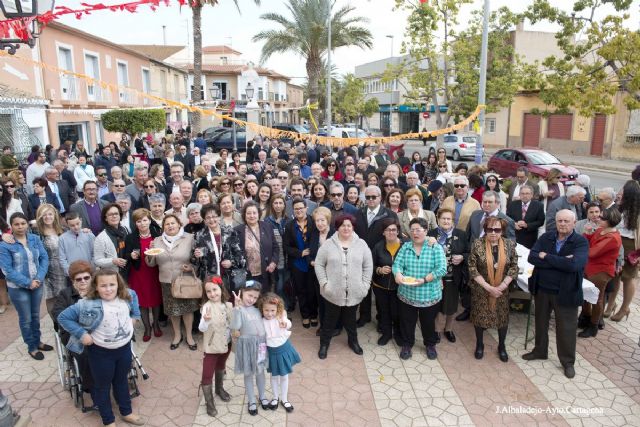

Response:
(529, 231), (589, 307)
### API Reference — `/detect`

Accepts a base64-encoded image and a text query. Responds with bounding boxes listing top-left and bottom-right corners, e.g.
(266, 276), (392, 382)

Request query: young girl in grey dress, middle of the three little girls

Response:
(231, 280), (270, 415)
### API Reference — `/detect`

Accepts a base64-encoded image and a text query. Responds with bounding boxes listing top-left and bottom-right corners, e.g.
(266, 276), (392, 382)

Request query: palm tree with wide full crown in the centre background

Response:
(253, 0), (373, 133)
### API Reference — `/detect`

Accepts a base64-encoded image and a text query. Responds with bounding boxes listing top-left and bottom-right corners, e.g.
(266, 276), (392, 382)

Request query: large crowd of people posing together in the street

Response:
(0, 132), (640, 425)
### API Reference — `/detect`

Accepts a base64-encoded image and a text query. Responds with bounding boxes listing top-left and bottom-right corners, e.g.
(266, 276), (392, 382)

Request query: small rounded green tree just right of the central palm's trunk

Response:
(333, 73), (378, 124)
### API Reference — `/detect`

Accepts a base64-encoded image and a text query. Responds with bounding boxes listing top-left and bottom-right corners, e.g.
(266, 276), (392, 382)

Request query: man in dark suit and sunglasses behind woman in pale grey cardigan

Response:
(355, 185), (398, 328)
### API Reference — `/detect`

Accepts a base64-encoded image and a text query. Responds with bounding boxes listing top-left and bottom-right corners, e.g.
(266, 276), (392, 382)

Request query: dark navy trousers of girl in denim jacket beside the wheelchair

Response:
(85, 342), (132, 425)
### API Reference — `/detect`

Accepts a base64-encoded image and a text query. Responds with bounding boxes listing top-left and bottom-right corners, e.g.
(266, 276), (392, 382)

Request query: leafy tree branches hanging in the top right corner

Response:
(524, 0), (640, 116)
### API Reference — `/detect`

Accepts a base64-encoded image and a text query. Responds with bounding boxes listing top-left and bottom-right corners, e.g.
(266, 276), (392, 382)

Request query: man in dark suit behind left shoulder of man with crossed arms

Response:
(507, 185), (544, 249)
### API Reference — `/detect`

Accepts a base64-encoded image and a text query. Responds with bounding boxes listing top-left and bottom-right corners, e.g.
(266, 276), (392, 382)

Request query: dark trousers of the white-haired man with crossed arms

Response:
(532, 291), (578, 366)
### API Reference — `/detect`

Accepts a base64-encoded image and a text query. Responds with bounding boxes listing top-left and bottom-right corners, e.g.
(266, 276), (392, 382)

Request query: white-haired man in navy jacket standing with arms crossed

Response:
(522, 209), (589, 378)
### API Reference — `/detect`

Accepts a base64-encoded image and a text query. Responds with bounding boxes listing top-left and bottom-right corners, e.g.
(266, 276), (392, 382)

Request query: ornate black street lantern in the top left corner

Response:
(0, 0), (55, 55)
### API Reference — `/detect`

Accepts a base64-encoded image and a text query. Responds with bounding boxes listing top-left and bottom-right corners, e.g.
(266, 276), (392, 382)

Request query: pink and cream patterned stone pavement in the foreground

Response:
(0, 292), (640, 427)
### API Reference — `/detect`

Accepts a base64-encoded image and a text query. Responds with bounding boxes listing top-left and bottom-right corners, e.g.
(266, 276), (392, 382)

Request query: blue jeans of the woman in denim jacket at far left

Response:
(8, 286), (42, 353)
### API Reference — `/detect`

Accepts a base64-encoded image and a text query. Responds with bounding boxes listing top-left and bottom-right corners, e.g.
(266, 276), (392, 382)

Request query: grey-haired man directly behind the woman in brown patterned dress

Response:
(456, 190), (516, 322)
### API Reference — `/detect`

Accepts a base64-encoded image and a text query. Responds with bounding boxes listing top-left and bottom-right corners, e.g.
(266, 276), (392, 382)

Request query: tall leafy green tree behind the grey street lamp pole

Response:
(384, 0), (524, 128)
